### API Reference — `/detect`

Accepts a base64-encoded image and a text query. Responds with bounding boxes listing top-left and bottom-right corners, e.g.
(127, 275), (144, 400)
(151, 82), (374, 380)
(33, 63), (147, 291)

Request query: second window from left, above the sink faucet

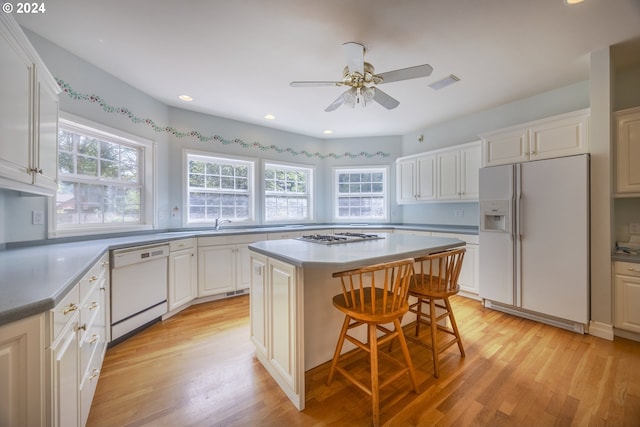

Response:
(186, 152), (254, 224)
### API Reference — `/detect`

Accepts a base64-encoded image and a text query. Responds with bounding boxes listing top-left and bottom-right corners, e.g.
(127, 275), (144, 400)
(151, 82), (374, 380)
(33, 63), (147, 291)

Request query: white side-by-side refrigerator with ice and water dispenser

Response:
(479, 154), (590, 332)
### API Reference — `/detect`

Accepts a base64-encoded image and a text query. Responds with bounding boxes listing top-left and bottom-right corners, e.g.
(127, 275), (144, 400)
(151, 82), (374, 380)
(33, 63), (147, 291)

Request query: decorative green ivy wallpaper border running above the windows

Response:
(56, 78), (389, 159)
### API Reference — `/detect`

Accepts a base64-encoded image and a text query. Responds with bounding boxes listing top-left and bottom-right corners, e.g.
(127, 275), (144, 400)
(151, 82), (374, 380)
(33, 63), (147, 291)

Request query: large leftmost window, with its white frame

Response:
(55, 118), (154, 235)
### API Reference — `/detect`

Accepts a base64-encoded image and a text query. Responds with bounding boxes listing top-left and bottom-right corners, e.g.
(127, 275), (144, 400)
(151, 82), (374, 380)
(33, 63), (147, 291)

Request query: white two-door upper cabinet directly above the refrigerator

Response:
(481, 109), (589, 166)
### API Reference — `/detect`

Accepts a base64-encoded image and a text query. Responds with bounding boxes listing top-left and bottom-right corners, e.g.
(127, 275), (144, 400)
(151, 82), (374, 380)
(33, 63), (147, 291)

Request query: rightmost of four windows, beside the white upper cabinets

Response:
(334, 167), (389, 221)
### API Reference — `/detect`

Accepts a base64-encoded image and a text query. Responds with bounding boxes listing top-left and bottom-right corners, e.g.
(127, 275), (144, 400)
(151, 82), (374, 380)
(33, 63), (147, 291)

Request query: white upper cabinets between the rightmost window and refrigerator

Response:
(396, 141), (480, 204)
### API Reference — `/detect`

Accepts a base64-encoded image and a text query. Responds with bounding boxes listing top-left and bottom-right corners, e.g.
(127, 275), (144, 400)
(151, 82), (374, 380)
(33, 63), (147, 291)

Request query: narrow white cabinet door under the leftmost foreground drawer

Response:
(51, 324), (80, 427)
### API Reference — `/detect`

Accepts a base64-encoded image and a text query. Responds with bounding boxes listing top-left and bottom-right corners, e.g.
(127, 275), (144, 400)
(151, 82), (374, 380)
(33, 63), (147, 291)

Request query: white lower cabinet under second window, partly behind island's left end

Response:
(198, 234), (267, 297)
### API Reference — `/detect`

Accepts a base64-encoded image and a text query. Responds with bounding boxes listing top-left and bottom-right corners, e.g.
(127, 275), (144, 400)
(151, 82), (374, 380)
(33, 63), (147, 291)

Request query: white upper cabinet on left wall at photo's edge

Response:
(0, 14), (60, 195)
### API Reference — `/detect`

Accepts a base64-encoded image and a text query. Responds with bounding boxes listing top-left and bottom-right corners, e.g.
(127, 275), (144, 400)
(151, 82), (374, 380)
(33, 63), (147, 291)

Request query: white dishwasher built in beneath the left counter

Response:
(111, 244), (169, 342)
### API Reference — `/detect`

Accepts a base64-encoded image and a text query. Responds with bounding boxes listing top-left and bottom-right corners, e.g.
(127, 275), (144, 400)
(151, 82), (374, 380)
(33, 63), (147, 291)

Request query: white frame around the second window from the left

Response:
(182, 148), (257, 228)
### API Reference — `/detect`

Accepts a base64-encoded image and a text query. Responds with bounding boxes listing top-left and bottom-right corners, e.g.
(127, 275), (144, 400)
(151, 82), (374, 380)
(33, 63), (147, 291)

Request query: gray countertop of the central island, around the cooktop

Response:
(249, 233), (465, 271)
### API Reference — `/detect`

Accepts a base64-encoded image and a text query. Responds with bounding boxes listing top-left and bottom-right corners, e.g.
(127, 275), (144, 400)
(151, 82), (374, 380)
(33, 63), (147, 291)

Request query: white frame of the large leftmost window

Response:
(47, 111), (158, 238)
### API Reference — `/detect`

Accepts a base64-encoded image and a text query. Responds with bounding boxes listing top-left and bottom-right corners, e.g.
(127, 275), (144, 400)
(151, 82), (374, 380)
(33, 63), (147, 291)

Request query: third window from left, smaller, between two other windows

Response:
(264, 163), (313, 222)
